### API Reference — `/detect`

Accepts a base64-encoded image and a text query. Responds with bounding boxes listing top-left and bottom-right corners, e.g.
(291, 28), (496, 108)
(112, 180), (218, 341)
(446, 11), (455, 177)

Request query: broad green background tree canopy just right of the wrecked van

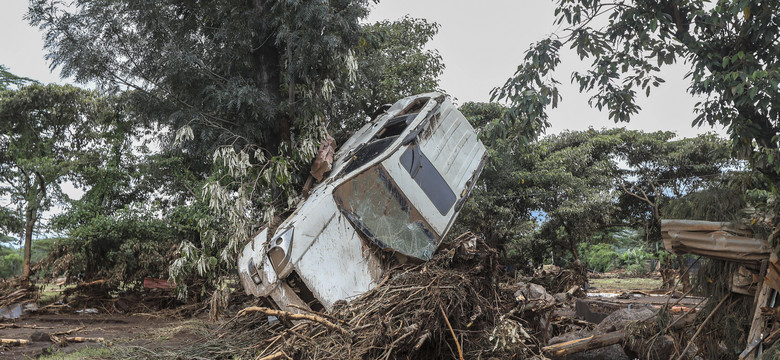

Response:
(455, 119), (744, 272)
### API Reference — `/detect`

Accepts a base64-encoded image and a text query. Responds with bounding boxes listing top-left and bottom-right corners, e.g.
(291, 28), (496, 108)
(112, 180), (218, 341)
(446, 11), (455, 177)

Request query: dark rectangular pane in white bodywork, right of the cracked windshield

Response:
(400, 145), (456, 215)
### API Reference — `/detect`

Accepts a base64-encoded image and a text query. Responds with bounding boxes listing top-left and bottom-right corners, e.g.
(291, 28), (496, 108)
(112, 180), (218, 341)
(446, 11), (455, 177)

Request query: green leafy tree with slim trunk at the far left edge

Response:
(0, 84), (123, 279)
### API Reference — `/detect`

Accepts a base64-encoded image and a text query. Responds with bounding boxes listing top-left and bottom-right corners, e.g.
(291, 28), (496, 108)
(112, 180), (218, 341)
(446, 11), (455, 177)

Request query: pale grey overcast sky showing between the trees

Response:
(0, 0), (724, 137)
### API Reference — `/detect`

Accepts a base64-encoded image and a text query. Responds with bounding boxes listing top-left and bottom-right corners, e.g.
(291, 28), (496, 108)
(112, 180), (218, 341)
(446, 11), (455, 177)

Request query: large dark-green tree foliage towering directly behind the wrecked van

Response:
(28, 0), (450, 298)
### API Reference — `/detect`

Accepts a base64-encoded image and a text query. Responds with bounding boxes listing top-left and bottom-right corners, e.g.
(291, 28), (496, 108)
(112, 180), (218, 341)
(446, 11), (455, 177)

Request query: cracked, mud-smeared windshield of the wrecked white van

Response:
(333, 165), (438, 260)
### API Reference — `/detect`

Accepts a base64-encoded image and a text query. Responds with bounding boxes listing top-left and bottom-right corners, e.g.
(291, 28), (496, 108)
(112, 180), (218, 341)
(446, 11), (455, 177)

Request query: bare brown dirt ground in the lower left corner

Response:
(0, 314), (211, 359)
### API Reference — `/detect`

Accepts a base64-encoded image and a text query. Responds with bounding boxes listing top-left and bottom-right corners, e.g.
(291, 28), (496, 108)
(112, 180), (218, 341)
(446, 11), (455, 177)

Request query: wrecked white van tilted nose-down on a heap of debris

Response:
(238, 93), (486, 313)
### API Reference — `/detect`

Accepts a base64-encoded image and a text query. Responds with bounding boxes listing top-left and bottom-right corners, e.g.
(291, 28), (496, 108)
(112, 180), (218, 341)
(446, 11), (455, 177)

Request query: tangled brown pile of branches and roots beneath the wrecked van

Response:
(131, 233), (552, 360)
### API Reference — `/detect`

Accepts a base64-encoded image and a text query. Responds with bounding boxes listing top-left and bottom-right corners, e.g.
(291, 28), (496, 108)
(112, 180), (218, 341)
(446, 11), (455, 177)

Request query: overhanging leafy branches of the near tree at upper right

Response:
(492, 0), (780, 239)
